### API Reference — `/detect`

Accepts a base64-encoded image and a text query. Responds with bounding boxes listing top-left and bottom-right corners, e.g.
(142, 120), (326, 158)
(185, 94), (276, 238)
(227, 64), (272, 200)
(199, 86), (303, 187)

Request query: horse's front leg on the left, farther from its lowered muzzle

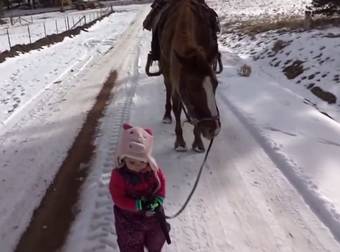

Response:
(172, 95), (188, 152)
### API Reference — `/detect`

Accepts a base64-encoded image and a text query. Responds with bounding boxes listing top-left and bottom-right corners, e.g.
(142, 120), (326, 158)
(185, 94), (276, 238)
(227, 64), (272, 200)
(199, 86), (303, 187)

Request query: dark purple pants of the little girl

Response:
(114, 206), (165, 252)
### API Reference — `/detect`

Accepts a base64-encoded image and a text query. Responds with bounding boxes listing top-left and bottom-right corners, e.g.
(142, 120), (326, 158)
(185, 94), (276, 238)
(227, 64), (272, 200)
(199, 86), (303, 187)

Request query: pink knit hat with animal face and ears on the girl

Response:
(116, 123), (158, 171)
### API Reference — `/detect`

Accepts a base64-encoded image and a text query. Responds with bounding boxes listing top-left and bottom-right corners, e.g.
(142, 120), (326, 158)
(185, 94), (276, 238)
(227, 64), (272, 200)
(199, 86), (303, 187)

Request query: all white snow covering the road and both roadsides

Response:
(0, 0), (340, 252)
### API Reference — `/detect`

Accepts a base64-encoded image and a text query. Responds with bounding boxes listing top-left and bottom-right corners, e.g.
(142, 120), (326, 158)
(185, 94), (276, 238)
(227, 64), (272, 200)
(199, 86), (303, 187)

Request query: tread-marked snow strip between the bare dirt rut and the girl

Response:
(64, 8), (148, 252)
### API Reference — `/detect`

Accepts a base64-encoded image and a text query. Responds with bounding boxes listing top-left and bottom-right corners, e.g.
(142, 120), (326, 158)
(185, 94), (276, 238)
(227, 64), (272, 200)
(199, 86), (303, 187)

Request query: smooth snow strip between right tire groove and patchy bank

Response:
(221, 53), (340, 240)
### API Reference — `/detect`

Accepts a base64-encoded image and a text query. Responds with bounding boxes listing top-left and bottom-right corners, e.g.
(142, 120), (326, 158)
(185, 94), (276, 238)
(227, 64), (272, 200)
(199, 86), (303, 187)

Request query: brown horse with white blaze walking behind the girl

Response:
(157, 0), (221, 152)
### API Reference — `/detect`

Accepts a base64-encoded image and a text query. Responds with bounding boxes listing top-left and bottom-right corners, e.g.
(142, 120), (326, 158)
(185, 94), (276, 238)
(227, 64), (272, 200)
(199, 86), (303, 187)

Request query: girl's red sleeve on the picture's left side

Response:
(109, 170), (137, 211)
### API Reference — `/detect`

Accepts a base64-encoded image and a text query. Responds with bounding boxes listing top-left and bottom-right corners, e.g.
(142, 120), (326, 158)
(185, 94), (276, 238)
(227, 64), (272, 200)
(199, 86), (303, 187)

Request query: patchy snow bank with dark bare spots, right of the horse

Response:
(221, 28), (340, 122)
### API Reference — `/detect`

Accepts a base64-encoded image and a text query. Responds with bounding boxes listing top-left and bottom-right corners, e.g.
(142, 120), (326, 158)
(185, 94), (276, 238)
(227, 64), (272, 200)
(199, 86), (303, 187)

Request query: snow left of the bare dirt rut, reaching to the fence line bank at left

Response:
(0, 7), (136, 252)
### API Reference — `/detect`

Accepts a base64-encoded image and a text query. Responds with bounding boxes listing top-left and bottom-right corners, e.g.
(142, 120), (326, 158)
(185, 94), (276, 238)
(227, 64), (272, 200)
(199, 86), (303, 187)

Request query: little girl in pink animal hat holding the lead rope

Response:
(110, 124), (168, 252)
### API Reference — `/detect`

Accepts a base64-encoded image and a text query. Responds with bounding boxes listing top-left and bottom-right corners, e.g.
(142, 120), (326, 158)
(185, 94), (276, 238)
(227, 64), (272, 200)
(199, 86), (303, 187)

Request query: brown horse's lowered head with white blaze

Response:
(175, 48), (221, 139)
